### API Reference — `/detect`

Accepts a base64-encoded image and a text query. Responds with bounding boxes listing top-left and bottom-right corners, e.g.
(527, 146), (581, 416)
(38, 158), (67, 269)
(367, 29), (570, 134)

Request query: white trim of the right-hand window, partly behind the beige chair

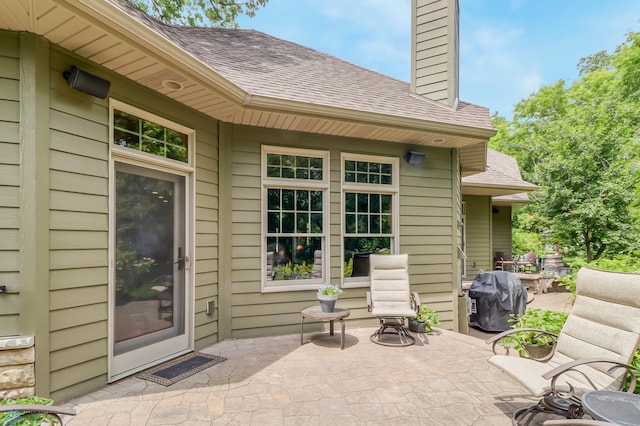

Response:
(340, 152), (400, 288)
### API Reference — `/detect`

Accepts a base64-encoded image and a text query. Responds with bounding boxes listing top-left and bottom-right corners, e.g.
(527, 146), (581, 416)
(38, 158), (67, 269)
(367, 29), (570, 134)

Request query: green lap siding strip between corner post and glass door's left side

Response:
(49, 50), (109, 400)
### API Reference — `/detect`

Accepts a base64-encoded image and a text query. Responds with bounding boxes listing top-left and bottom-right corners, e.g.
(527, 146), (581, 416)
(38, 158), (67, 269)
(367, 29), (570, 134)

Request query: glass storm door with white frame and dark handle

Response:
(110, 163), (190, 379)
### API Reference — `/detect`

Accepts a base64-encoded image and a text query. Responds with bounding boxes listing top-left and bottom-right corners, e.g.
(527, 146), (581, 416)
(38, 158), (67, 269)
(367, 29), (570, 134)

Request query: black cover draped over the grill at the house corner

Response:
(469, 271), (527, 331)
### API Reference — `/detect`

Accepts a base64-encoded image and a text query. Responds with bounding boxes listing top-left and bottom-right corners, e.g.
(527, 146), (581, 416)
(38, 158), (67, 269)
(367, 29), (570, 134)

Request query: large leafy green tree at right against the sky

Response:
(491, 34), (640, 261)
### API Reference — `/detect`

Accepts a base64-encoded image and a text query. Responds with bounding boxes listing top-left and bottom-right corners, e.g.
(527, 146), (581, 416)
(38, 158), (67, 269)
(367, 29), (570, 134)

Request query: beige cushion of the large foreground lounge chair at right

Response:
(488, 268), (640, 395)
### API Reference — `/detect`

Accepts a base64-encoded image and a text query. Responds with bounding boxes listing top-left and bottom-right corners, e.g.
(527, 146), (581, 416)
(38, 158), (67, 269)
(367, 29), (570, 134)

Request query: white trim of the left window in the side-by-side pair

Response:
(260, 145), (331, 293)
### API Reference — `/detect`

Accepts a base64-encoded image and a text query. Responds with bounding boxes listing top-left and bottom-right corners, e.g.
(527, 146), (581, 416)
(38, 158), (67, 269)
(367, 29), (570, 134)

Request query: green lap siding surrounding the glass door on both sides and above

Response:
(45, 51), (218, 399)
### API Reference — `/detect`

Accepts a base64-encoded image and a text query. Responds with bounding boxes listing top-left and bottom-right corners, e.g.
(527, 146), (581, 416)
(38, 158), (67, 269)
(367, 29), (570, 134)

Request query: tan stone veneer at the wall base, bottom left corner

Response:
(0, 336), (36, 400)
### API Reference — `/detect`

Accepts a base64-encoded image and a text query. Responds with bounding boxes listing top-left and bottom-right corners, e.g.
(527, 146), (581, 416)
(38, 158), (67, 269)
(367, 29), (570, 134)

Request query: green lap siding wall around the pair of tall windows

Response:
(225, 126), (454, 338)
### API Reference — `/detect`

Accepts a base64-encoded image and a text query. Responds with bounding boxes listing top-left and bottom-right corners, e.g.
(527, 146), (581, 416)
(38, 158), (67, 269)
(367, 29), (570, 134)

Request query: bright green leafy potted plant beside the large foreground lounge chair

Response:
(502, 308), (568, 359)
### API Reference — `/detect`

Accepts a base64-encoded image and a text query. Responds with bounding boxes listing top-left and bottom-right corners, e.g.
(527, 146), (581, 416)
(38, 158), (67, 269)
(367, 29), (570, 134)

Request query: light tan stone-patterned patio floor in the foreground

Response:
(64, 327), (552, 426)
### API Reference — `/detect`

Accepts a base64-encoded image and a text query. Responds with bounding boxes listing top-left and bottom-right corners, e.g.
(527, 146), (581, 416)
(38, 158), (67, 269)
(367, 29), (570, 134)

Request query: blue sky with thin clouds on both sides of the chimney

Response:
(238, 0), (640, 118)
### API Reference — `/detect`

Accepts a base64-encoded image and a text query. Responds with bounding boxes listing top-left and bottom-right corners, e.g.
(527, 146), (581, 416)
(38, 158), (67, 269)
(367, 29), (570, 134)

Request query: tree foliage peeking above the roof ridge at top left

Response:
(130, 0), (269, 28)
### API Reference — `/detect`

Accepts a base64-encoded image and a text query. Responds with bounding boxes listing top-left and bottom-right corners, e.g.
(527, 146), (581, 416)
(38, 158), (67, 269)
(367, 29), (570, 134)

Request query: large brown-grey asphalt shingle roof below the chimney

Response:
(110, 0), (491, 129)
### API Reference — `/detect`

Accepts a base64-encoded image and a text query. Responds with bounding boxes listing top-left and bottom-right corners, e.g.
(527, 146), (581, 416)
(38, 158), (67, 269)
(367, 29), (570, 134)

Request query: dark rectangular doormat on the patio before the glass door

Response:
(136, 352), (226, 386)
